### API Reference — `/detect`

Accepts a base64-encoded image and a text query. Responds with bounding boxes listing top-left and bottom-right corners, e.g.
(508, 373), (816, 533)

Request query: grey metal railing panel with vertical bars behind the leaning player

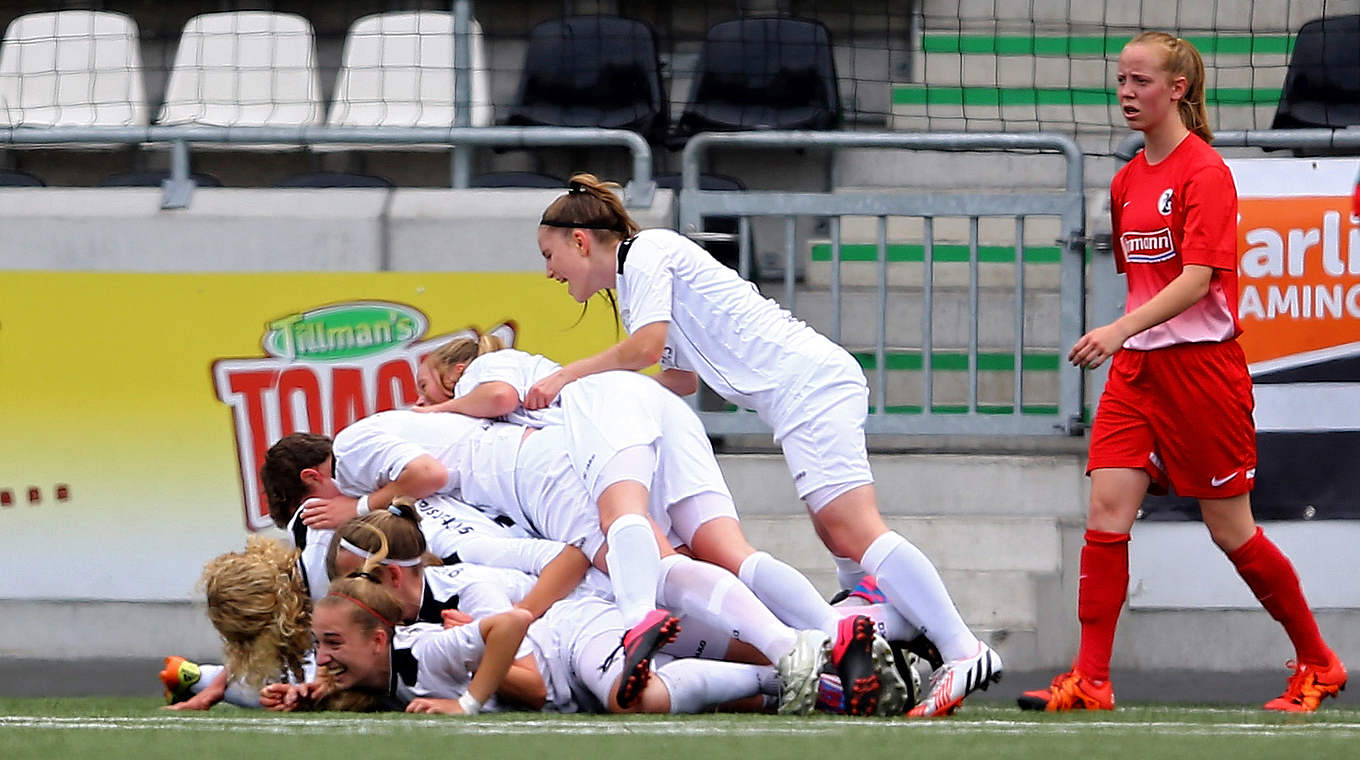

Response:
(679, 132), (1085, 435)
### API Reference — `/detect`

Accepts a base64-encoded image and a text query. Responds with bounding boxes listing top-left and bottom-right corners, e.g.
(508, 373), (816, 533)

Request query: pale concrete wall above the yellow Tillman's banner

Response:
(0, 188), (675, 272)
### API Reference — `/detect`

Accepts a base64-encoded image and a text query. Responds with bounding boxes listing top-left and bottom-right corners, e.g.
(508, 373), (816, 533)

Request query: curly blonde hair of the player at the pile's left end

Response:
(201, 536), (311, 689)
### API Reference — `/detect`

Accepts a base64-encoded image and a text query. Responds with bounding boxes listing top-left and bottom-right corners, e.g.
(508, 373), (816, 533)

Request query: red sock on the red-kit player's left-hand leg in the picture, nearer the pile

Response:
(1076, 530), (1129, 681)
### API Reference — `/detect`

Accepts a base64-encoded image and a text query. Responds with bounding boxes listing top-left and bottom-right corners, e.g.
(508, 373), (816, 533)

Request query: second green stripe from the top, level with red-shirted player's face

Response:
(892, 84), (1280, 106)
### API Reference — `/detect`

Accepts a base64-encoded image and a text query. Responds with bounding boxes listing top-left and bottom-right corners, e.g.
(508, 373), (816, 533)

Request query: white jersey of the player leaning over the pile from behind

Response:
(617, 230), (862, 441)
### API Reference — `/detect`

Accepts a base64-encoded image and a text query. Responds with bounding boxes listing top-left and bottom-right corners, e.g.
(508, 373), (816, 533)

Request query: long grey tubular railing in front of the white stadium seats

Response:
(0, 125), (656, 208)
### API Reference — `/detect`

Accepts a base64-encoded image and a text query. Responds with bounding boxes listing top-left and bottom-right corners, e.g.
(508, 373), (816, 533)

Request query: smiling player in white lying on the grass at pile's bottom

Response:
(261, 557), (779, 715)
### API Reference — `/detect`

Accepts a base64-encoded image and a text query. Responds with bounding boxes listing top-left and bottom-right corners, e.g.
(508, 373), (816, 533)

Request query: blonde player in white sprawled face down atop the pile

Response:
(416, 336), (906, 715)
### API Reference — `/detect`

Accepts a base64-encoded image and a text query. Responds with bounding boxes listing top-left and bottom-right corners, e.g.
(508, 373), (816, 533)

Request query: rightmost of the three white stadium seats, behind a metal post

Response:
(326, 11), (492, 126)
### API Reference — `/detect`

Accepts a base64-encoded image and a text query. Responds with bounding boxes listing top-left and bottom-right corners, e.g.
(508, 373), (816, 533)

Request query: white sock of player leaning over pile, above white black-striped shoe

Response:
(860, 530), (978, 659)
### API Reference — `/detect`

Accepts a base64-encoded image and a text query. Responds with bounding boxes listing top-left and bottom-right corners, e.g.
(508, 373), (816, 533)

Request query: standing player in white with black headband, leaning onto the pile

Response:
(525, 174), (1001, 715)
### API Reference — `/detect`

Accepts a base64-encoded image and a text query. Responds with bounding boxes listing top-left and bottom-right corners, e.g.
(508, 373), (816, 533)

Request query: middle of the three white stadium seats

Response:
(156, 11), (322, 126)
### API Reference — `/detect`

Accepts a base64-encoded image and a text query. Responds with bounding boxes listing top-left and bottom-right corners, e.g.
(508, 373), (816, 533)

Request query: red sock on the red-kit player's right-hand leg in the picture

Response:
(1228, 528), (1331, 668)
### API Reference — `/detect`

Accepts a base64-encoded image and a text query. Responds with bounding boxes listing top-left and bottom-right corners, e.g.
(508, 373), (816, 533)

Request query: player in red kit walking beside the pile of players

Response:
(1020, 31), (1346, 712)
